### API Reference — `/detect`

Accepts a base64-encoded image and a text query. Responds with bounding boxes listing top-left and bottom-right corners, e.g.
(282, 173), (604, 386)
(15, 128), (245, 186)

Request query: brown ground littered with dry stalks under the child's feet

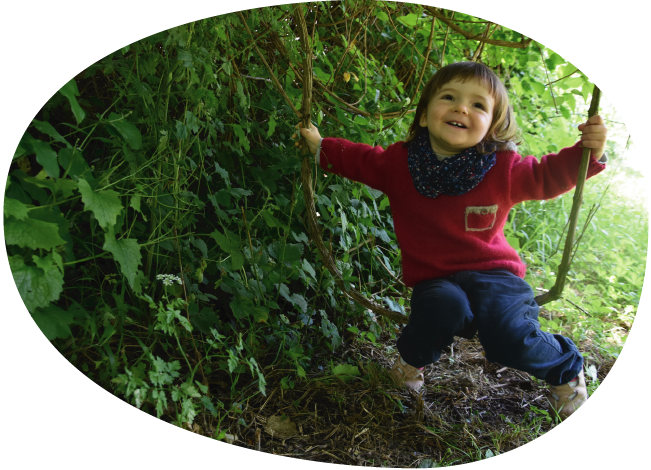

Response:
(193, 332), (614, 468)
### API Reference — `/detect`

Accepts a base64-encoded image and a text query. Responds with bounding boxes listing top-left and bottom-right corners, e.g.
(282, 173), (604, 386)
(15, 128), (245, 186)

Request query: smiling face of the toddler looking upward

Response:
(420, 80), (495, 155)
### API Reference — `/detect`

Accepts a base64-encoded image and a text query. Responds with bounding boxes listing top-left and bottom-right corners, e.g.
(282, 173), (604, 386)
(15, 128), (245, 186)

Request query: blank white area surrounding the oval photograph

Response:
(0, 0), (651, 469)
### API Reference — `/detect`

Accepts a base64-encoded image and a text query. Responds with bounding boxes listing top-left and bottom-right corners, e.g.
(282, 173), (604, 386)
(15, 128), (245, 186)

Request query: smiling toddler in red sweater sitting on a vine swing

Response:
(296, 62), (607, 419)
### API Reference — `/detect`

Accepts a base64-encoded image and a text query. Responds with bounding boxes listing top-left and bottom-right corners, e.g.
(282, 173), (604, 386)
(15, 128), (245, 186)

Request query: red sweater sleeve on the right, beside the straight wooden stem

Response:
(511, 144), (606, 204)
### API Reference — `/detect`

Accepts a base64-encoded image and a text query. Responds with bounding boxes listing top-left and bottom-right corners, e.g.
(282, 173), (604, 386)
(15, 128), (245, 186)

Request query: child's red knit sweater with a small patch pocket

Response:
(319, 138), (605, 287)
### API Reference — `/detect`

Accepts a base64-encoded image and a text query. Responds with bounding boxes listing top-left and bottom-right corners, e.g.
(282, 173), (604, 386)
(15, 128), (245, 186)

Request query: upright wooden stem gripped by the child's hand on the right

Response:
(535, 85), (601, 305)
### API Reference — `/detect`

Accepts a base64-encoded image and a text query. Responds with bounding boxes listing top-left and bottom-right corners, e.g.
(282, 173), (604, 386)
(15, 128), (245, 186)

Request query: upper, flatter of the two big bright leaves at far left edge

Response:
(4, 213), (66, 250)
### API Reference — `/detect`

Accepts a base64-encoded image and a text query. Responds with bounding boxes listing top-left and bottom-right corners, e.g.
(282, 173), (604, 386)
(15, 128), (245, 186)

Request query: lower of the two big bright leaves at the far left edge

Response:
(9, 253), (63, 313)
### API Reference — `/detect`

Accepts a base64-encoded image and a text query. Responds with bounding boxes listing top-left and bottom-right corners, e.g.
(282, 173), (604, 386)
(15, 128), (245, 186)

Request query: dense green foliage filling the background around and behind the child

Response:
(3, 0), (648, 444)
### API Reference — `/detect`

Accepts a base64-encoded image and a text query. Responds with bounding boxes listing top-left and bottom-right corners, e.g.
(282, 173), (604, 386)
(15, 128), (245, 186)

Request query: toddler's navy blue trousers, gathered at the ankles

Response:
(398, 269), (583, 385)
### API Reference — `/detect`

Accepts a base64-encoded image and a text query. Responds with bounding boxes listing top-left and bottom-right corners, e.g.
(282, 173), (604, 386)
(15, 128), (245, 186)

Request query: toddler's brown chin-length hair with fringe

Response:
(405, 62), (520, 154)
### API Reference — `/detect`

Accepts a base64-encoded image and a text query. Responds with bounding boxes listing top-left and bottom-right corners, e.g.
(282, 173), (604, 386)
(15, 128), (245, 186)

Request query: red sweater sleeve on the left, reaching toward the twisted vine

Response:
(319, 137), (389, 192)
